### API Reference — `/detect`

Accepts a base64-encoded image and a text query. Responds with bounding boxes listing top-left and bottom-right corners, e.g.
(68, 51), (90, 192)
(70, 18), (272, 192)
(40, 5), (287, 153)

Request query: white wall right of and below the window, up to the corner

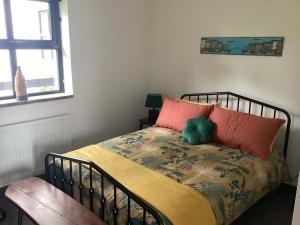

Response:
(0, 0), (149, 149)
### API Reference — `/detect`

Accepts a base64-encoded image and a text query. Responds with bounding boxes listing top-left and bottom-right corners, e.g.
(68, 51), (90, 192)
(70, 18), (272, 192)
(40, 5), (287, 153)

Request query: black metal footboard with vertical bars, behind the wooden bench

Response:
(45, 153), (164, 225)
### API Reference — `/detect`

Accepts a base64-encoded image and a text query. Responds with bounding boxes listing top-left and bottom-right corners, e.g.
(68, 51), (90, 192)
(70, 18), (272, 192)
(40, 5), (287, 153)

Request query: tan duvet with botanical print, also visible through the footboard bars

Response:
(52, 127), (285, 225)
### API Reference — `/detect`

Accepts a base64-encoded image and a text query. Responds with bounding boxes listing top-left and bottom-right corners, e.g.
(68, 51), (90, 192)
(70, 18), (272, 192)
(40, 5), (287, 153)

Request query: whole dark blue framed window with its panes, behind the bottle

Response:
(0, 0), (64, 99)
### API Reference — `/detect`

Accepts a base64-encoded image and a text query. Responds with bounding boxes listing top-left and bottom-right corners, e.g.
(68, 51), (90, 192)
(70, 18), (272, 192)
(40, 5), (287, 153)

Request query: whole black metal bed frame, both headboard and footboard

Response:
(45, 92), (291, 225)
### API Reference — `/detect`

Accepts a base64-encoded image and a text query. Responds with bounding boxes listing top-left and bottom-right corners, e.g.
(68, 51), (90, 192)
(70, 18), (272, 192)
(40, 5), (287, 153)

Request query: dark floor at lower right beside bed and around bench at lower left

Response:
(0, 183), (295, 225)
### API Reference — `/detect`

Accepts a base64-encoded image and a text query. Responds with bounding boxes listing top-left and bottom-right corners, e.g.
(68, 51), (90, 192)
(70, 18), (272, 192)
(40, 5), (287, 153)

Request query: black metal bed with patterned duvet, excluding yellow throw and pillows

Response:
(45, 92), (291, 225)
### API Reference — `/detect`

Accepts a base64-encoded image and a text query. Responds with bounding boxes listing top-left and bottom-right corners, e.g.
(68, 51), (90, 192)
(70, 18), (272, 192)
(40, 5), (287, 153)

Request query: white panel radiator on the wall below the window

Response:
(0, 114), (71, 187)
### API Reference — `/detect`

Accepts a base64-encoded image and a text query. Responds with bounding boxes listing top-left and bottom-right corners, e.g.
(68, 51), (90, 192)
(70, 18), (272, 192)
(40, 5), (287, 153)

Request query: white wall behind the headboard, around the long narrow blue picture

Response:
(148, 0), (300, 179)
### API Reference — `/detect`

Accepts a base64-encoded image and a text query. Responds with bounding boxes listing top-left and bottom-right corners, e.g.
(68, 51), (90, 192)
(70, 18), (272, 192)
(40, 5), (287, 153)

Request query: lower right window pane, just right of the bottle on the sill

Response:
(17, 50), (59, 94)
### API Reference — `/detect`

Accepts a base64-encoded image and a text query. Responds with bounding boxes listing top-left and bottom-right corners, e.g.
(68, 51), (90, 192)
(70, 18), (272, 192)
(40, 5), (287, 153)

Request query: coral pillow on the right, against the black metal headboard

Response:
(209, 107), (285, 159)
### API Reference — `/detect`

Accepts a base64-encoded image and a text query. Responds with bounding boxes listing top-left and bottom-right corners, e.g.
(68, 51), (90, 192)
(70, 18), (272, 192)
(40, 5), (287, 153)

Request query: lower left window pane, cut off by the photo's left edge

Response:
(0, 50), (13, 97)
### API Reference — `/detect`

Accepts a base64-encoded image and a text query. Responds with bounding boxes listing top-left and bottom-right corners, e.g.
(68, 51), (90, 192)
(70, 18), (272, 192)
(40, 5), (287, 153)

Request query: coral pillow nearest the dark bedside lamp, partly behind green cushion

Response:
(155, 98), (213, 132)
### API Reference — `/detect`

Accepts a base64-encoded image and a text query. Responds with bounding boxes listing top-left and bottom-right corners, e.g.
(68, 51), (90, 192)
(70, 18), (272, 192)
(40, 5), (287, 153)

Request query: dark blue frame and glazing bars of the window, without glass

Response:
(0, 0), (65, 100)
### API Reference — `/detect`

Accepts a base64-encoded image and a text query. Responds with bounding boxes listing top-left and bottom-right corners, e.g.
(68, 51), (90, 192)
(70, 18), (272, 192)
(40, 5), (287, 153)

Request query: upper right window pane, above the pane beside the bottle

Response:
(11, 0), (51, 40)
